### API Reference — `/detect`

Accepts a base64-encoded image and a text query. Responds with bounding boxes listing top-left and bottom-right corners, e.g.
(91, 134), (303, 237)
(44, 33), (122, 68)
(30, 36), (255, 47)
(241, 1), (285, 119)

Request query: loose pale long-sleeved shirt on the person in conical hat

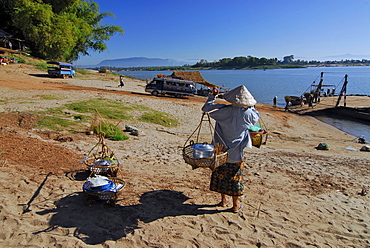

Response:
(202, 94), (259, 163)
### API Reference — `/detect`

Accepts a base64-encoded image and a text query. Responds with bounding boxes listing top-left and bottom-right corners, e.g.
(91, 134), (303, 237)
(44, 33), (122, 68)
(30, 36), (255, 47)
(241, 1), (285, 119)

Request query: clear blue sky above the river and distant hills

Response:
(74, 0), (370, 65)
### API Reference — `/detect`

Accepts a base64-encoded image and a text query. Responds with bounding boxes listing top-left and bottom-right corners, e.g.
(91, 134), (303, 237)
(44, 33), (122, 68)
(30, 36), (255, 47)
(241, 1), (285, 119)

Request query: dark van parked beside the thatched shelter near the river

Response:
(145, 78), (196, 97)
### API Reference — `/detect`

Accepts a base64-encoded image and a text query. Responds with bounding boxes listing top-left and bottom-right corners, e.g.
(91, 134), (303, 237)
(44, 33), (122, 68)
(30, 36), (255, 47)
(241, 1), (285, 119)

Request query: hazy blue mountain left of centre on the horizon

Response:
(97, 57), (196, 67)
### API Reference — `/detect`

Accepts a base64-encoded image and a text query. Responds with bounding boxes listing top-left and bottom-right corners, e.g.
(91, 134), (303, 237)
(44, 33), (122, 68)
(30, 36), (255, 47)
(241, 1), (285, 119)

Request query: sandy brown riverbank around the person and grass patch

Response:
(0, 64), (370, 248)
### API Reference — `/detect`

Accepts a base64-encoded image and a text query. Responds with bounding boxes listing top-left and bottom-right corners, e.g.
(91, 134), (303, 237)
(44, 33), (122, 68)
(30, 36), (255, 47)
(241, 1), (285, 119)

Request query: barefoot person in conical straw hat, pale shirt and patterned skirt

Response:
(202, 85), (259, 213)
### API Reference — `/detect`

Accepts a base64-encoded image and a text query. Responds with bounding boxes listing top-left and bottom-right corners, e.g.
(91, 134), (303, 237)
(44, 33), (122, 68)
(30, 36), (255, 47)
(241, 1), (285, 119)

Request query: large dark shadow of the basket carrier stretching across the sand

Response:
(34, 190), (228, 245)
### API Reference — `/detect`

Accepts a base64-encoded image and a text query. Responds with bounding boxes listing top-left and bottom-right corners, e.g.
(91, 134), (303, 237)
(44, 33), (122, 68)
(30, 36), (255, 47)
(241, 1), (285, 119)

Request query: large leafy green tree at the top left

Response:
(0, 0), (123, 61)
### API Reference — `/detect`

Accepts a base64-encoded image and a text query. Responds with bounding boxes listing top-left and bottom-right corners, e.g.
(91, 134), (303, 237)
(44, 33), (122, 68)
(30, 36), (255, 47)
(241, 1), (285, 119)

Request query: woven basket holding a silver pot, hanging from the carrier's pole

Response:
(182, 145), (228, 170)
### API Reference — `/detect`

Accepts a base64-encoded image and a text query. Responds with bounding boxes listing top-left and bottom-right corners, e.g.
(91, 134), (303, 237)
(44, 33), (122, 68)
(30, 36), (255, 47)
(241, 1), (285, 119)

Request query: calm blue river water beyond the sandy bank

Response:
(119, 66), (370, 141)
